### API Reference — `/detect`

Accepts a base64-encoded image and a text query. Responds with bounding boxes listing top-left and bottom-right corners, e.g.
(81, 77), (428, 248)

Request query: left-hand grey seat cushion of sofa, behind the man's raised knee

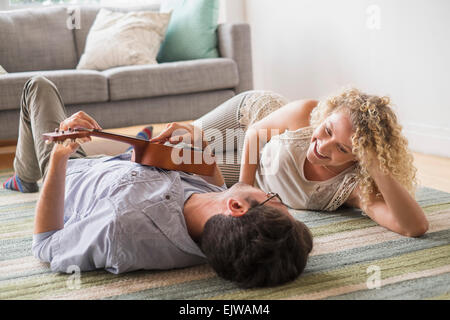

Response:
(0, 70), (108, 110)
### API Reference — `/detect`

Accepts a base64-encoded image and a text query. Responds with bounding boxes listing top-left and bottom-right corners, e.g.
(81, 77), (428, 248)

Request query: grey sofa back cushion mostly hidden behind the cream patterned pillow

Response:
(72, 3), (159, 59)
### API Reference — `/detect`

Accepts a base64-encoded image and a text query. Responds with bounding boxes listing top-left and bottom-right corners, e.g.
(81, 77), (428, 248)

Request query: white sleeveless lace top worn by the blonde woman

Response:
(255, 127), (357, 211)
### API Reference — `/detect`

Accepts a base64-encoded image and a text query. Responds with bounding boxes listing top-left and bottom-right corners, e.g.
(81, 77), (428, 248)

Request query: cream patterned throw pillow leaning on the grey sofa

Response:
(77, 9), (171, 70)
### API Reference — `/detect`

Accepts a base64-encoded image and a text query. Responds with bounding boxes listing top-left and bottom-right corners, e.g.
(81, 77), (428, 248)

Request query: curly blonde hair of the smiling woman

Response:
(311, 88), (417, 208)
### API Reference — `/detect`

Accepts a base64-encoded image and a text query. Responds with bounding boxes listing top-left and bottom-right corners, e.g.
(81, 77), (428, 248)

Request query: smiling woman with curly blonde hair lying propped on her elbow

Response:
(154, 88), (428, 237)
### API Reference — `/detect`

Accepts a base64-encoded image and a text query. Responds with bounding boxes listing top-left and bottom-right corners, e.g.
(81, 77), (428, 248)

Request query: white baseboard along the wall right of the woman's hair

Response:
(403, 122), (450, 157)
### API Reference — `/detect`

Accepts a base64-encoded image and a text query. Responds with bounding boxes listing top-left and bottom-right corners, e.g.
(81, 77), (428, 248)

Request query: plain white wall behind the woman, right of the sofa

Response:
(243, 0), (450, 157)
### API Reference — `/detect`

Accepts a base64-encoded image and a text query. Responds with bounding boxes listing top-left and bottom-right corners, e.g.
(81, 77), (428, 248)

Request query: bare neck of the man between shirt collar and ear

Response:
(183, 193), (223, 241)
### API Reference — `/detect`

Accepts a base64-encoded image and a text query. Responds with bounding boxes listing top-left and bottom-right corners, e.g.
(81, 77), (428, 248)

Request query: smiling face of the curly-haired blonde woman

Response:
(307, 112), (356, 166)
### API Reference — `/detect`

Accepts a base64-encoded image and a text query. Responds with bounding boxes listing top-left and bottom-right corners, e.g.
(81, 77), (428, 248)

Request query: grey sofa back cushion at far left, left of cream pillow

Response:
(0, 7), (77, 72)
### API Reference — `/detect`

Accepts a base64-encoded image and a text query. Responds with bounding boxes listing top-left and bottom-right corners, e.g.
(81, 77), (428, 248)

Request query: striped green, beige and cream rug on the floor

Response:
(0, 171), (450, 300)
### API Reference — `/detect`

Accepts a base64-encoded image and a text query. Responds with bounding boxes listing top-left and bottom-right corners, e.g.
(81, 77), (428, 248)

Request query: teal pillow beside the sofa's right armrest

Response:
(156, 0), (219, 63)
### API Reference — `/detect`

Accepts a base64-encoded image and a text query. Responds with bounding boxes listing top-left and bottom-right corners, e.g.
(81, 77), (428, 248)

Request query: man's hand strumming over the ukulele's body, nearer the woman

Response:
(149, 122), (208, 149)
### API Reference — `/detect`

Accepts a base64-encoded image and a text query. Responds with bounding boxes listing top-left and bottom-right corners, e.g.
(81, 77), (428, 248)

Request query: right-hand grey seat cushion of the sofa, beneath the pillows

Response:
(103, 58), (239, 101)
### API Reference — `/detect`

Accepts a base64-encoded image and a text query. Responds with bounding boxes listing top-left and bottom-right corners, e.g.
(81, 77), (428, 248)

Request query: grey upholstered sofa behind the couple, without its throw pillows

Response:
(0, 5), (253, 140)
